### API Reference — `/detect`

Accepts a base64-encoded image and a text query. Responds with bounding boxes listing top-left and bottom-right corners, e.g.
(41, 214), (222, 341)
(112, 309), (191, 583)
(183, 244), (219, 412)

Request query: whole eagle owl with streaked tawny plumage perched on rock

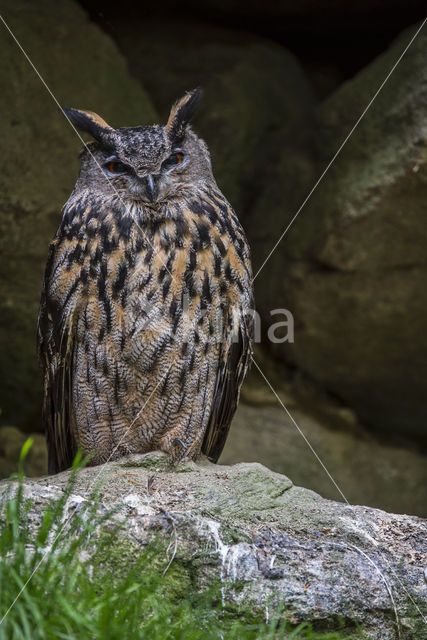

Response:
(38, 89), (253, 473)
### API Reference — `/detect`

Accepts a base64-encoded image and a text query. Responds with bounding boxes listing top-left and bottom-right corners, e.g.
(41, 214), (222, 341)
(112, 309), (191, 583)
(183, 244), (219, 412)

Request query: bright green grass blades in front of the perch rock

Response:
(0, 444), (358, 640)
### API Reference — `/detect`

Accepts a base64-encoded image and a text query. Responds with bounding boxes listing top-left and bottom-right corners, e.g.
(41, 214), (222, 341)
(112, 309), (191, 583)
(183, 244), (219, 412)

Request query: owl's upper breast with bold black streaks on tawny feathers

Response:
(48, 192), (252, 366)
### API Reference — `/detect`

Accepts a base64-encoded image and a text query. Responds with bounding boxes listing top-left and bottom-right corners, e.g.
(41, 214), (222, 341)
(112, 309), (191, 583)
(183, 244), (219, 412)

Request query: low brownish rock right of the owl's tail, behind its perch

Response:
(220, 404), (427, 517)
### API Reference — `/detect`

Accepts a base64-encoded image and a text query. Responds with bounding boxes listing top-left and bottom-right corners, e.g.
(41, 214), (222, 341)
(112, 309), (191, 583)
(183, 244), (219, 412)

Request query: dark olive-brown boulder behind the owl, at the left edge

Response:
(0, 0), (156, 431)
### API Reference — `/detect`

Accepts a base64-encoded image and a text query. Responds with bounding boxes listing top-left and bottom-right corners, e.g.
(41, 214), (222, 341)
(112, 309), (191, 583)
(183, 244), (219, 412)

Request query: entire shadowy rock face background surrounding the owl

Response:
(0, 0), (427, 514)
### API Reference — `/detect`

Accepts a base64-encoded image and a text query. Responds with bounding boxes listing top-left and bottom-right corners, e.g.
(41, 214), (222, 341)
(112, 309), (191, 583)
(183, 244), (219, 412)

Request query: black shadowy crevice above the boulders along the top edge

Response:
(80, 0), (425, 92)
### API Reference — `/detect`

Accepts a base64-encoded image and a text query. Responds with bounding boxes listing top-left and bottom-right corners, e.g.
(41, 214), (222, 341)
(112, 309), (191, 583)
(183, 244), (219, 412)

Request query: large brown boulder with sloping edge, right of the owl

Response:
(254, 25), (427, 442)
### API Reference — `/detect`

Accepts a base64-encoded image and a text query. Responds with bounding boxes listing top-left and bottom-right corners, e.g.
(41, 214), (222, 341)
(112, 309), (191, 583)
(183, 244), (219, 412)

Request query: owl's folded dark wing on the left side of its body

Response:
(37, 247), (77, 474)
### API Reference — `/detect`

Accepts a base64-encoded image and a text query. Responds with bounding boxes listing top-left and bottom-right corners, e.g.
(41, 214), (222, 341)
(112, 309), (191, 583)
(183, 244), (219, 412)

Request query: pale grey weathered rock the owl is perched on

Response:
(0, 452), (427, 640)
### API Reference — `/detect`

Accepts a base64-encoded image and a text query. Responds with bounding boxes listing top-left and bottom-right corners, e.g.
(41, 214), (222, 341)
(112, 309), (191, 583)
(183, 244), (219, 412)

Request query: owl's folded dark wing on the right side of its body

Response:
(202, 308), (253, 462)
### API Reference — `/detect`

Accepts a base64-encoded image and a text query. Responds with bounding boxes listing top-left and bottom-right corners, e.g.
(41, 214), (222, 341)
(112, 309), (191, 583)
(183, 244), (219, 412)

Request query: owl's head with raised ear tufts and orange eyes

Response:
(62, 88), (214, 206)
